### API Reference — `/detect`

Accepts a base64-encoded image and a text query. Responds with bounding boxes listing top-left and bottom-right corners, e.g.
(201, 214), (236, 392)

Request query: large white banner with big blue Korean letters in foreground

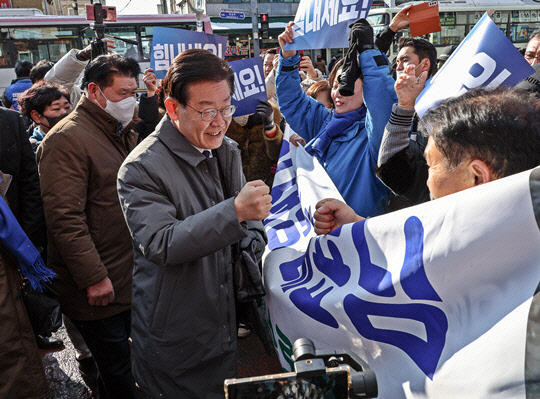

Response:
(264, 135), (540, 399)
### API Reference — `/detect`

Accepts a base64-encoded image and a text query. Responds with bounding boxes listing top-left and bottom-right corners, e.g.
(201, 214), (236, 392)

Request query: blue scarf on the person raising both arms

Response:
(307, 105), (366, 162)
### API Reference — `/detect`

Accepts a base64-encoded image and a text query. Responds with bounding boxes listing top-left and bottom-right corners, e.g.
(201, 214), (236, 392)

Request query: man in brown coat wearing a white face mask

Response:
(36, 54), (141, 398)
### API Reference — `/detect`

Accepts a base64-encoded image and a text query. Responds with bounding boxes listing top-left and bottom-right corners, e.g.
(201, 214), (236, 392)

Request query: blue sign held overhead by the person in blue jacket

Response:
(285, 0), (373, 50)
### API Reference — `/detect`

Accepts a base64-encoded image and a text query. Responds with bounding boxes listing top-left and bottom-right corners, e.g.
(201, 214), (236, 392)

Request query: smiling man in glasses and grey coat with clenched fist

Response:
(118, 49), (272, 399)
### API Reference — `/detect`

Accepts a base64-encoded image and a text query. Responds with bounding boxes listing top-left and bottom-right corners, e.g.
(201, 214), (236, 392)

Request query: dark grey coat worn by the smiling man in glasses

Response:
(118, 116), (265, 399)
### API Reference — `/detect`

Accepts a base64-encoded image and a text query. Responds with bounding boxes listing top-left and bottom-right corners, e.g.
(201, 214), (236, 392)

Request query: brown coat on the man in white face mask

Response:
(37, 95), (137, 320)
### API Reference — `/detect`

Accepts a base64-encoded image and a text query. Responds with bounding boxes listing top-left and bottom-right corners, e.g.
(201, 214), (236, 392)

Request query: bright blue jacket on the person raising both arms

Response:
(276, 50), (397, 217)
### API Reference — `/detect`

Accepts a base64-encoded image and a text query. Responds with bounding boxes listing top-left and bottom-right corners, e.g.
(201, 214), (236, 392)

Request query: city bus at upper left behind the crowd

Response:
(0, 9), (212, 93)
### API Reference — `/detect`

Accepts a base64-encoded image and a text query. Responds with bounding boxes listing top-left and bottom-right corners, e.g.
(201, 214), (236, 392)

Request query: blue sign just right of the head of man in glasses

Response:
(229, 57), (266, 116)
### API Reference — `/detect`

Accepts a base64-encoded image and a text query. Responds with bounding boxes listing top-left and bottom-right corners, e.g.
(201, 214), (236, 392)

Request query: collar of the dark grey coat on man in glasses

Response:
(156, 115), (239, 167)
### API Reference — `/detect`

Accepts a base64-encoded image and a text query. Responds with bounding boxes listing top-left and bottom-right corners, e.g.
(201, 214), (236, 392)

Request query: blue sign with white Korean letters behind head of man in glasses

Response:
(150, 26), (227, 79)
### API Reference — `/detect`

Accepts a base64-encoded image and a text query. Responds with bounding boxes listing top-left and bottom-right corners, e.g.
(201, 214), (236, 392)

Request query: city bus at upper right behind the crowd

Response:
(367, 0), (540, 60)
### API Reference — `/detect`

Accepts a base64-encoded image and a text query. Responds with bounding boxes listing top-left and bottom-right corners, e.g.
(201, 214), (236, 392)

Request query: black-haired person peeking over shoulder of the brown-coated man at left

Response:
(19, 82), (71, 152)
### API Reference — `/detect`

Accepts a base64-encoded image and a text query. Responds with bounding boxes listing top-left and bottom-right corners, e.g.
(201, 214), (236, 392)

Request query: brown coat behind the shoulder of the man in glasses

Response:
(226, 106), (283, 187)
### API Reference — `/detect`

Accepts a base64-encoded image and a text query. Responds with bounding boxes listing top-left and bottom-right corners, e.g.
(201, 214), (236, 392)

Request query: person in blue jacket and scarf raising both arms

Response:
(276, 20), (397, 216)
